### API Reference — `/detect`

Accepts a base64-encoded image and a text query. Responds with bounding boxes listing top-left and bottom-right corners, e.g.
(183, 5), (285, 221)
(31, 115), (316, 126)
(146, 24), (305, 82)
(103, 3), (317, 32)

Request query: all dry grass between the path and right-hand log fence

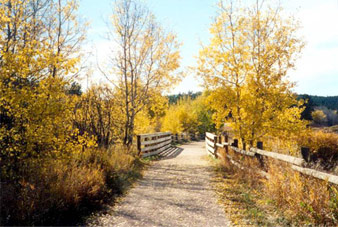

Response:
(217, 146), (338, 226)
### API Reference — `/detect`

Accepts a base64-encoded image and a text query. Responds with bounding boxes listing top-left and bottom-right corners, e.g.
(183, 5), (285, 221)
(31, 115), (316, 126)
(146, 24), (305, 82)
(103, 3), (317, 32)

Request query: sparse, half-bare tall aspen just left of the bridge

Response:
(107, 0), (180, 146)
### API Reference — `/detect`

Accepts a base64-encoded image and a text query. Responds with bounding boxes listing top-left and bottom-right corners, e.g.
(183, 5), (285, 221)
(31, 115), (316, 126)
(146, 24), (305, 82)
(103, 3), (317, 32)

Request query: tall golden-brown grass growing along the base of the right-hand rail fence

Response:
(218, 140), (338, 226)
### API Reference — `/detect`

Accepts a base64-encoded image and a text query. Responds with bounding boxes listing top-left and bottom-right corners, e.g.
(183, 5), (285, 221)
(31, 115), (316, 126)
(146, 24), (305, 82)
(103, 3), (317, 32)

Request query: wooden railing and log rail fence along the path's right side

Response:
(205, 132), (338, 184)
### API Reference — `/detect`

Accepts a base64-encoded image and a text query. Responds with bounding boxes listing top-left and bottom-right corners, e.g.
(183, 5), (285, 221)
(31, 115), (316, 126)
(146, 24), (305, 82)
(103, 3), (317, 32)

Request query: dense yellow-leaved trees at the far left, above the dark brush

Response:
(0, 0), (94, 179)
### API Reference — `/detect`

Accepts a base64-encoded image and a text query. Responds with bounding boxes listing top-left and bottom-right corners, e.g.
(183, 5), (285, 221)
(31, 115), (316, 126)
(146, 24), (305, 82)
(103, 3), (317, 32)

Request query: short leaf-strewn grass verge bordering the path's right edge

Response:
(214, 157), (288, 226)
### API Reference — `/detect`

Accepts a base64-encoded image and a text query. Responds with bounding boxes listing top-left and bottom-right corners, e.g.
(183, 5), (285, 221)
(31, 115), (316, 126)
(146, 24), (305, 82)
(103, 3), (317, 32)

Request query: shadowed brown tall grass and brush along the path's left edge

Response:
(0, 146), (142, 225)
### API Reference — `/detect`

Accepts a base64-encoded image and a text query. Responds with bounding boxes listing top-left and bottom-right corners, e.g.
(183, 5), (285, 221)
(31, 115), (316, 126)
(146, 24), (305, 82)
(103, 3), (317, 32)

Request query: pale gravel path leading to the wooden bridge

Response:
(88, 142), (230, 227)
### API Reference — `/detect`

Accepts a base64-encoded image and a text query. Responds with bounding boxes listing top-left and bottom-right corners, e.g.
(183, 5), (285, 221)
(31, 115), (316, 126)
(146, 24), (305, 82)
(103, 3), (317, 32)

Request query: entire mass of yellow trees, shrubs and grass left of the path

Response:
(0, 0), (180, 225)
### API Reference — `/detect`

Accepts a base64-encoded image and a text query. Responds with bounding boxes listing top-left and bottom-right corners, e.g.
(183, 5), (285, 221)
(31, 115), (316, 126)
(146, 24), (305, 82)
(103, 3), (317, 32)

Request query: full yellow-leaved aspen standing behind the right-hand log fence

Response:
(197, 1), (305, 145)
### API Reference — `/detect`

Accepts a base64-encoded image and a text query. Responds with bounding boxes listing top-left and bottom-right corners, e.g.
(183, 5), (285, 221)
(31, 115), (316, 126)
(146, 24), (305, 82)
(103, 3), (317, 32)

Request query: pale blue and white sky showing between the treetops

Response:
(79, 0), (338, 96)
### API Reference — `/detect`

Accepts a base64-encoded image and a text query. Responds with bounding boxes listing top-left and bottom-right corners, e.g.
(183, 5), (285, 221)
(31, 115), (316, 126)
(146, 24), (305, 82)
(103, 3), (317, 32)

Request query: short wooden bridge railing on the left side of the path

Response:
(137, 132), (172, 157)
